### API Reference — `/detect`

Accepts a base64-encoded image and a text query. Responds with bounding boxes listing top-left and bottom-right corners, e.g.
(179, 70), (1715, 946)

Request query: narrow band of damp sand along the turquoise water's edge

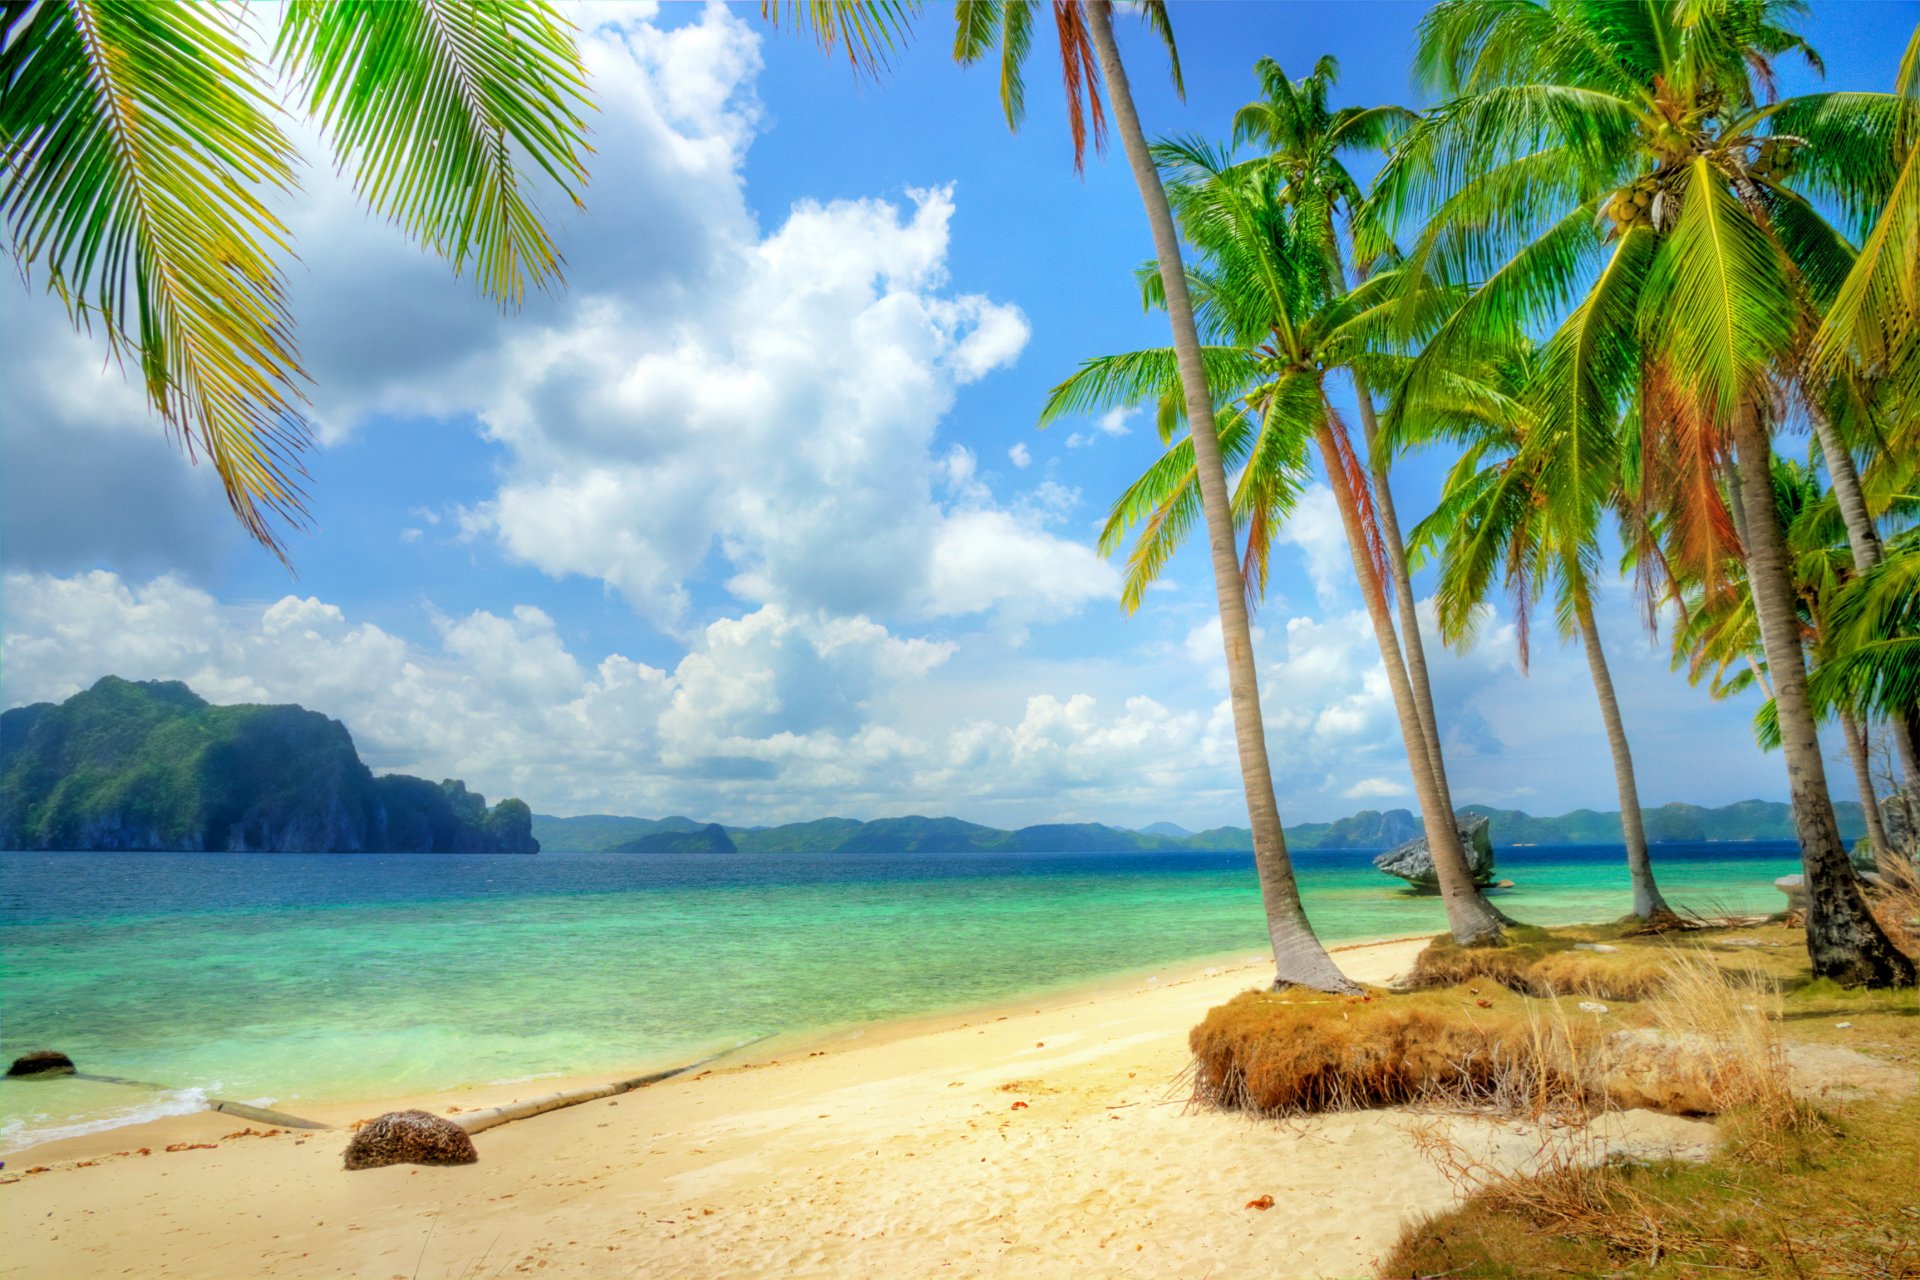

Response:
(0, 935), (1432, 1173)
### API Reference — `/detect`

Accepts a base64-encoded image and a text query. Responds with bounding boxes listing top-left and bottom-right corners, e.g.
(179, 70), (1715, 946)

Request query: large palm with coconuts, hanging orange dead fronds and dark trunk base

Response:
(1379, 0), (1914, 986)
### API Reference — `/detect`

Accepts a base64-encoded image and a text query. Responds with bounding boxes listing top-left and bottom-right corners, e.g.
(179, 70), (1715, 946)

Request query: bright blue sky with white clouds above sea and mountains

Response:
(0, 2), (1920, 825)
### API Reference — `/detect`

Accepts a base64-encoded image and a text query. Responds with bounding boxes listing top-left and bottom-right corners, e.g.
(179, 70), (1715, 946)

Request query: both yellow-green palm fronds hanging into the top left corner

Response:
(0, 0), (588, 558)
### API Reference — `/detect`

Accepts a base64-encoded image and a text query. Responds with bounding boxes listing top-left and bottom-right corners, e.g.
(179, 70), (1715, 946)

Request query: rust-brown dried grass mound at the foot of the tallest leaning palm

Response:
(1188, 986), (1601, 1115)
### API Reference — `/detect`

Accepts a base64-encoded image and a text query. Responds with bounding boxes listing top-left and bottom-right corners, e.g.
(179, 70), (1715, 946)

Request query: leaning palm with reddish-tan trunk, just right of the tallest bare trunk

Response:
(1043, 142), (1503, 942)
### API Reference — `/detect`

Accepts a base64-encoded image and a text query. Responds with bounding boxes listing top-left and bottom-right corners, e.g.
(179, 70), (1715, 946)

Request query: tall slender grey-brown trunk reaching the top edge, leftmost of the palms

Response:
(1085, 0), (1359, 992)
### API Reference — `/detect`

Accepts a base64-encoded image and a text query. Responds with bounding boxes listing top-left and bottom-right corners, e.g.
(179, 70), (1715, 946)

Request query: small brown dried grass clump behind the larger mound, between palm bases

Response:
(1407, 929), (1670, 1000)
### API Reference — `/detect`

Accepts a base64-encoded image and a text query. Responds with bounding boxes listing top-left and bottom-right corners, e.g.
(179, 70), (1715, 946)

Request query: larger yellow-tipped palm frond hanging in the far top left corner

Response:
(0, 0), (305, 553)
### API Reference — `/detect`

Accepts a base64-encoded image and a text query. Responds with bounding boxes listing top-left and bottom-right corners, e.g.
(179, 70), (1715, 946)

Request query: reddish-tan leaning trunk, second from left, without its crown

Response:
(1313, 409), (1509, 946)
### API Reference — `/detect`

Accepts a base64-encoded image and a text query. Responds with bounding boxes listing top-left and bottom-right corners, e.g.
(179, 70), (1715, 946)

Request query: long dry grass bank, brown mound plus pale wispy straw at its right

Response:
(1188, 942), (1805, 1132)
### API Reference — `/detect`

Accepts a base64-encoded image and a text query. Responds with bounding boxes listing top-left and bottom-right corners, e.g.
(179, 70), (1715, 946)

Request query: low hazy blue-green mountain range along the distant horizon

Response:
(534, 800), (1864, 854)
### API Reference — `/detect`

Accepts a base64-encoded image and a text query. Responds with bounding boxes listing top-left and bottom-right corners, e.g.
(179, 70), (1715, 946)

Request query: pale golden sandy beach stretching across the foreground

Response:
(0, 940), (1711, 1280)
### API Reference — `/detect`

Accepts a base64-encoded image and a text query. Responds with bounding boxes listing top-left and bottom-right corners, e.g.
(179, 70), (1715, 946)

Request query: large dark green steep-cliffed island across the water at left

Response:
(0, 676), (540, 854)
